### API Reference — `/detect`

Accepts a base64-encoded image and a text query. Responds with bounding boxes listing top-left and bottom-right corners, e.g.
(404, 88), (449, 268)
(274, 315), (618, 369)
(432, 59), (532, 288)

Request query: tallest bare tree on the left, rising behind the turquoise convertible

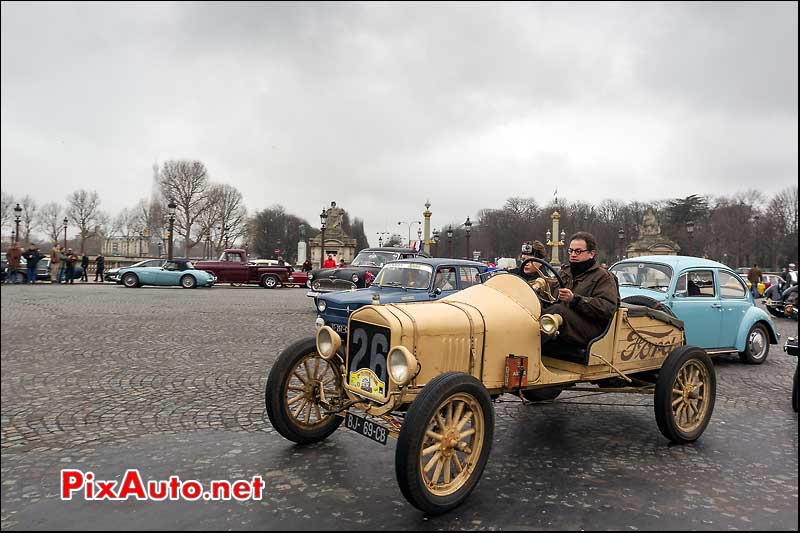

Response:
(159, 160), (208, 257)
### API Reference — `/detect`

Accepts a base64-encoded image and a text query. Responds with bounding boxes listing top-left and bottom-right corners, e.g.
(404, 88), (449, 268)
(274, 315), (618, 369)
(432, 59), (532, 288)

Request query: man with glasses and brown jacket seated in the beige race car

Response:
(547, 231), (619, 348)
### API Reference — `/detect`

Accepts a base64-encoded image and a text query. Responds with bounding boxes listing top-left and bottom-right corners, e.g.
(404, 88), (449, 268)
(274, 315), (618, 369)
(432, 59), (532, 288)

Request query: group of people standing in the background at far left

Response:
(6, 242), (105, 283)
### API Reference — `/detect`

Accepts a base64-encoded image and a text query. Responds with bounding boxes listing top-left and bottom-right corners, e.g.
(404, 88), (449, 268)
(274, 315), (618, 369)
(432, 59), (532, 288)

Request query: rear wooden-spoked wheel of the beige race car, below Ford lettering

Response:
(653, 346), (717, 444)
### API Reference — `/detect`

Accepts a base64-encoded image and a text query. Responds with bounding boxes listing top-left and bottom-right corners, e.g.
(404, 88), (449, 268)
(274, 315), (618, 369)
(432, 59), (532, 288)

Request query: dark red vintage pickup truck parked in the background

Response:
(194, 248), (294, 289)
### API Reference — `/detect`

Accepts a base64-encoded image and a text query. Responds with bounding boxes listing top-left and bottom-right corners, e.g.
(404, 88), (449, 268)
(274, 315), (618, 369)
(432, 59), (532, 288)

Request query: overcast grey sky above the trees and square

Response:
(0, 2), (798, 244)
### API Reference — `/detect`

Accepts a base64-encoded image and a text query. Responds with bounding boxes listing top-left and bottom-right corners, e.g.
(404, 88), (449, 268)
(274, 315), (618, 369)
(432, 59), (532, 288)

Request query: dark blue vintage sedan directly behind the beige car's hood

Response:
(315, 257), (487, 336)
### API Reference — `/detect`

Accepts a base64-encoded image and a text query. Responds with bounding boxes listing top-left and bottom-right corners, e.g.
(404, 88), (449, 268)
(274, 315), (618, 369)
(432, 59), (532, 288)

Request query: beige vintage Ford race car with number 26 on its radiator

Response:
(266, 260), (716, 514)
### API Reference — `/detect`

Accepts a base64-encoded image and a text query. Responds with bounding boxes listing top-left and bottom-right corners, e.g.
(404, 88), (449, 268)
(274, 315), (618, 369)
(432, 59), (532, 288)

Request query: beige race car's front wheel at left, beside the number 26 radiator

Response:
(264, 337), (344, 444)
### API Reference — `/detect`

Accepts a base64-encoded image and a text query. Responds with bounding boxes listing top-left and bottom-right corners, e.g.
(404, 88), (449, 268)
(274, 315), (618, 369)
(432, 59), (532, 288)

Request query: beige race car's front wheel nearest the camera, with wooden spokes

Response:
(395, 372), (494, 514)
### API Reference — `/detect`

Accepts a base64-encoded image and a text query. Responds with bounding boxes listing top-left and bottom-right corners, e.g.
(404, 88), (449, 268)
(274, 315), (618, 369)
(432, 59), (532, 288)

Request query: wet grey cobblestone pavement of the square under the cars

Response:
(0, 285), (798, 530)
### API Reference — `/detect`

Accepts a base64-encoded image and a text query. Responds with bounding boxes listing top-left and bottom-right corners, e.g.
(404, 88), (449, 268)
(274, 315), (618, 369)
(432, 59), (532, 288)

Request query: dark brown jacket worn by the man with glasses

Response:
(543, 264), (619, 348)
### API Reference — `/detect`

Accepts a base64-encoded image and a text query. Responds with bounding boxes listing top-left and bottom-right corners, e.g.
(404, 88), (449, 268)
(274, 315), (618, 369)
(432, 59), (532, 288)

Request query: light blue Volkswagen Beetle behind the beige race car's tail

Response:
(609, 255), (780, 364)
